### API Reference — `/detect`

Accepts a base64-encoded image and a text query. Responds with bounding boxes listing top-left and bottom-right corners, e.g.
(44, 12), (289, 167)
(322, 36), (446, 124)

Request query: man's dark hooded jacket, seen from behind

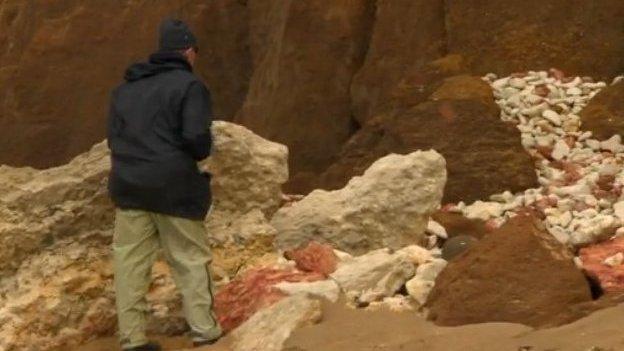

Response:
(108, 53), (212, 219)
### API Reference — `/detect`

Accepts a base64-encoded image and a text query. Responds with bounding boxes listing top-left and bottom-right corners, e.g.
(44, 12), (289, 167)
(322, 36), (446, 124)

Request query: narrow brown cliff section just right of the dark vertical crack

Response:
(351, 0), (445, 123)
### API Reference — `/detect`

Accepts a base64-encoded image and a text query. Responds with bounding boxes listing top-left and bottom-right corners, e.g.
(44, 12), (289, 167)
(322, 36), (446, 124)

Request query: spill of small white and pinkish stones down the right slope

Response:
(449, 69), (624, 247)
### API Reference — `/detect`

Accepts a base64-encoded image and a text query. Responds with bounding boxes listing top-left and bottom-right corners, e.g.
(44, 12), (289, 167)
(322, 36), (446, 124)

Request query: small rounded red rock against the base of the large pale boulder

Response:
(284, 241), (338, 276)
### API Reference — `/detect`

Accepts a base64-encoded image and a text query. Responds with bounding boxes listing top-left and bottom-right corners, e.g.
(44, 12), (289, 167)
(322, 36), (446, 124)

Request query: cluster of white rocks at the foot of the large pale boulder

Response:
(274, 245), (447, 311)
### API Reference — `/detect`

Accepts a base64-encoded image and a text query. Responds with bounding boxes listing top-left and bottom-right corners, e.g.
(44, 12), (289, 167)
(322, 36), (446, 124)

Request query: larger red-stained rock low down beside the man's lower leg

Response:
(214, 268), (325, 332)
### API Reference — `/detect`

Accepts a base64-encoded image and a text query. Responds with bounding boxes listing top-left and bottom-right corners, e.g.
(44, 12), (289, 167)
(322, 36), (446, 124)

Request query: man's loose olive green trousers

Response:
(113, 209), (221, 349)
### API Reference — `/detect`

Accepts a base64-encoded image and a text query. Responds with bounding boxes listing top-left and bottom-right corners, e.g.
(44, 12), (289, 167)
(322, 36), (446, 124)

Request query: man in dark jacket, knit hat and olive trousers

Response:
(108, 20), (221, 351)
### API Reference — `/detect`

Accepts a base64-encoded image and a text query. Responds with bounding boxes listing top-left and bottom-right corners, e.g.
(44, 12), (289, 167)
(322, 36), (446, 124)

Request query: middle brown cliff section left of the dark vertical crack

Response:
(236, 0), (372, 192)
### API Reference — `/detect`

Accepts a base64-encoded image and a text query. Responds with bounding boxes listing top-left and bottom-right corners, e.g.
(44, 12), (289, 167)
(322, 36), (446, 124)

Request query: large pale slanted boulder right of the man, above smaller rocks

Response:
(271, 150), (446, 253)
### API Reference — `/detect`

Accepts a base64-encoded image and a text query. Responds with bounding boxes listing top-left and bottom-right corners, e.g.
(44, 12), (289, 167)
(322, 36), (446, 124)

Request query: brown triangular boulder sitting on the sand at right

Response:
(426, 215), (592, 327)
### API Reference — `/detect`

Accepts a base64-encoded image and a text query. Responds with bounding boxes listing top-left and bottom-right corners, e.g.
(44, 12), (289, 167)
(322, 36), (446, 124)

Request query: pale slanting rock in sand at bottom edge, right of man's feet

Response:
(231, 295), (322, 351)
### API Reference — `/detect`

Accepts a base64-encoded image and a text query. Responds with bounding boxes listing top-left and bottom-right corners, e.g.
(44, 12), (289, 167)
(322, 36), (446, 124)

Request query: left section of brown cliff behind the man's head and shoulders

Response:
(0, 0), (251, 167)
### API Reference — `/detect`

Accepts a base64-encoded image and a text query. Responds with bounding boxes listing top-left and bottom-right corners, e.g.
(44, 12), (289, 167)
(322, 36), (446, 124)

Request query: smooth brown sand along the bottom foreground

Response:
(76, 304), (624, 351)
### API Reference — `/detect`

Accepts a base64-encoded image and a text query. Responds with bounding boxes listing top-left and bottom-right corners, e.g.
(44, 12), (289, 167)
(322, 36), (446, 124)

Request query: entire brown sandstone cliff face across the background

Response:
(0, 0), (624, 197)
